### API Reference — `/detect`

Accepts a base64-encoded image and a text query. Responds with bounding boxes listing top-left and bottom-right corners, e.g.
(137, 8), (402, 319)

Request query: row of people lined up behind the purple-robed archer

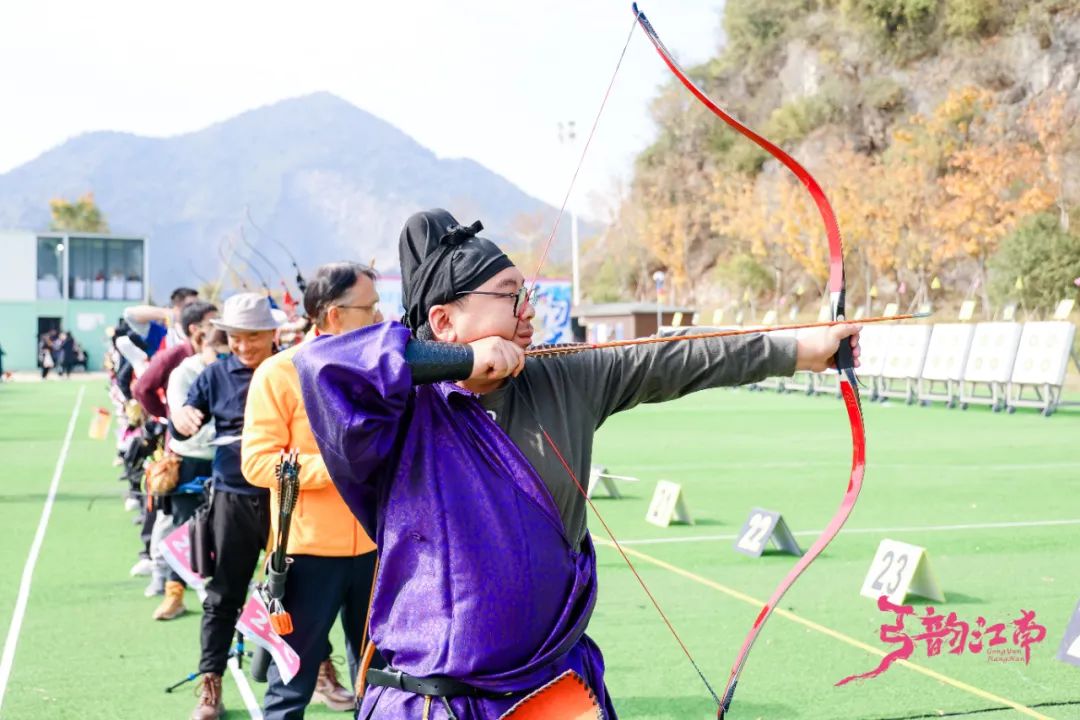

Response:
(102, 267), (382, 720)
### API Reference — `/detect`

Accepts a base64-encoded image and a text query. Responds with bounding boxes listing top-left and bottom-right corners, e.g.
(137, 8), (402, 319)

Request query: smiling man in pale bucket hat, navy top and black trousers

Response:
(170, 293), (281, 720)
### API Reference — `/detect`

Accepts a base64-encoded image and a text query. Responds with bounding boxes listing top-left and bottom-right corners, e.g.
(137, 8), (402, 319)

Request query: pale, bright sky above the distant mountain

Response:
(0, 0), (723, 215)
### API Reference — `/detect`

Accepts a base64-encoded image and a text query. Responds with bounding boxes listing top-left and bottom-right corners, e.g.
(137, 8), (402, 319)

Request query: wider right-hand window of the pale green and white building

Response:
(68, 237), (143, 300)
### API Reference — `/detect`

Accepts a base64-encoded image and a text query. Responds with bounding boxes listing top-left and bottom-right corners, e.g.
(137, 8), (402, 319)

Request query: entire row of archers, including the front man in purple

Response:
(99, 209), (860, 720)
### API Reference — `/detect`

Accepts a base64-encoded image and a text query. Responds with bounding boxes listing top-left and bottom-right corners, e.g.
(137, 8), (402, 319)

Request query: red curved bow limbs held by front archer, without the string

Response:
(633, 2), (866, 718)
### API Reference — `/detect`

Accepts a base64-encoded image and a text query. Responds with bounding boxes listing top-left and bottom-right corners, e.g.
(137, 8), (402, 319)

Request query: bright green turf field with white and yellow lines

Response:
(0, 381), (1080, 720)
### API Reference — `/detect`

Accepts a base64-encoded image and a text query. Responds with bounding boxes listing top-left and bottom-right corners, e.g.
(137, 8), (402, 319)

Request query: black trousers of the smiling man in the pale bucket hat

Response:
(199, 490), (270, 675)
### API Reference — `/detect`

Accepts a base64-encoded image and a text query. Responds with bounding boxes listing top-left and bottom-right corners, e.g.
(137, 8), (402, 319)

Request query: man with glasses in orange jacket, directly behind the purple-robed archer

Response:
(241, 262), (382, 720)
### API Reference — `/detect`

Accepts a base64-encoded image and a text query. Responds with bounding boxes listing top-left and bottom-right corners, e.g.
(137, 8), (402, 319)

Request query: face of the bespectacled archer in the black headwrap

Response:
(446, 268), (536, 348)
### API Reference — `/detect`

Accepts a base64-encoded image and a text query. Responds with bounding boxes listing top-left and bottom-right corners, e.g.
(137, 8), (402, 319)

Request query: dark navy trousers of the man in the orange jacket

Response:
(264, 551), (384, 720)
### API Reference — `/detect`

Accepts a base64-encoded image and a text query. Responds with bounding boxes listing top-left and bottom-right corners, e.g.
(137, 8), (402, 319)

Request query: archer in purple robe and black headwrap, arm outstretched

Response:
(294, 210), (858, 720)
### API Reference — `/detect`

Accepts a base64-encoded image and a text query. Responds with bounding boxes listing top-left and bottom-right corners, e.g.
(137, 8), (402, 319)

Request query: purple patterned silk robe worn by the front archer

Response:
(294, 323), (616, 720)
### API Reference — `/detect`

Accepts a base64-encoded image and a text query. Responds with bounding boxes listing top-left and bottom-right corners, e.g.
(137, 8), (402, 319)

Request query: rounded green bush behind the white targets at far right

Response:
(990, 213), (1080, 313)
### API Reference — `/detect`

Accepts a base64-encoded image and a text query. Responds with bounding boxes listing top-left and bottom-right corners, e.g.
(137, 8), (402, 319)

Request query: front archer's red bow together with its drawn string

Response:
(522, 2), (866, 719)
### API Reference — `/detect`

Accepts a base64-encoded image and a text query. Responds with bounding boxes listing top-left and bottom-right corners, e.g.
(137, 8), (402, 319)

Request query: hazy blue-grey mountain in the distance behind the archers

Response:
(0, 93), (583, 300)
